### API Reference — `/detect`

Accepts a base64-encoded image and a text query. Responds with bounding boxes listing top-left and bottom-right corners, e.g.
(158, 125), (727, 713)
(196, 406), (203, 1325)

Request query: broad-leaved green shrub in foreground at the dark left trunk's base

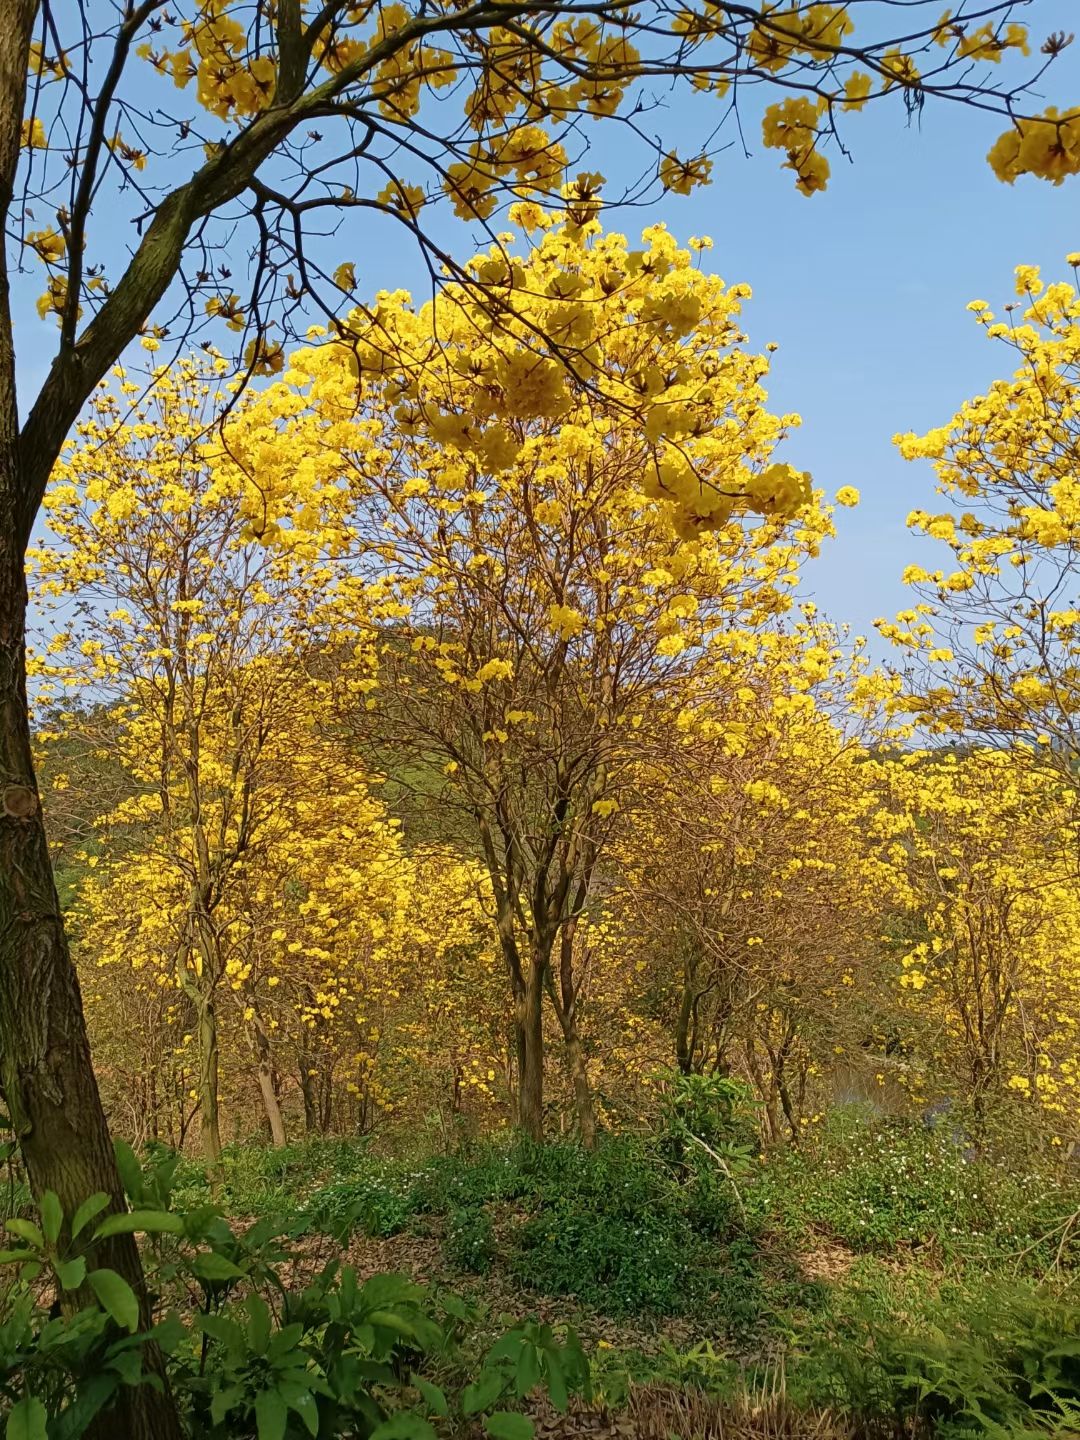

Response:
(0, 1145), (590, 1440)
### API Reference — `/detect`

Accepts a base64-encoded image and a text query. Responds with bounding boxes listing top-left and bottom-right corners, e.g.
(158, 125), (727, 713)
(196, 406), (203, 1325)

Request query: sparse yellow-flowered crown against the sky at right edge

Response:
(878, 255), (1080, 783)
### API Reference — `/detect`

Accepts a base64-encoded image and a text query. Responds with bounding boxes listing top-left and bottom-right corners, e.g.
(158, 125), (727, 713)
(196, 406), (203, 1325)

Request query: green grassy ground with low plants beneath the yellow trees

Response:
(148, 1113), (1080, 1440)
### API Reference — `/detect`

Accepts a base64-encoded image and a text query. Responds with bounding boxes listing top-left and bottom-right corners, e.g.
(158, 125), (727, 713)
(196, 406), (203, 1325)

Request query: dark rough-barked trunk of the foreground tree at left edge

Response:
(0, 457), (180, 1440)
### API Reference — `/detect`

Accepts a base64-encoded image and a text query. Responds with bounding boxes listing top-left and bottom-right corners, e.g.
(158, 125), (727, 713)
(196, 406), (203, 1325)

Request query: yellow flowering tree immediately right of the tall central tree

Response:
(606, 616), (877, 1142)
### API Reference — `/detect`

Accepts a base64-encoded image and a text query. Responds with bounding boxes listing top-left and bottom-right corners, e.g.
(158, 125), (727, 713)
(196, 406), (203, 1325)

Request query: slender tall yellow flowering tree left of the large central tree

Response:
(30, 361), (363, 1161)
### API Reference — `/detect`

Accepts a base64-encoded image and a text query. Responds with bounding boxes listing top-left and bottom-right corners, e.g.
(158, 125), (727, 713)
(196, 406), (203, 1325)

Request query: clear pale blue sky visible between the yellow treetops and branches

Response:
(14, 0), (1080, 650)
